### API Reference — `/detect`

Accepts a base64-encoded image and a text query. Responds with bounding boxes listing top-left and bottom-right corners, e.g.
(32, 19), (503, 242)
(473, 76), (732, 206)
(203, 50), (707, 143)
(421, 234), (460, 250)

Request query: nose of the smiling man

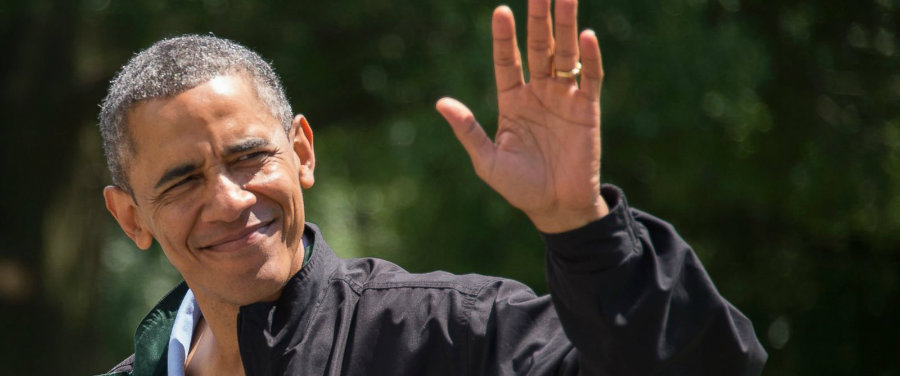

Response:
(202, 174), (256, 222)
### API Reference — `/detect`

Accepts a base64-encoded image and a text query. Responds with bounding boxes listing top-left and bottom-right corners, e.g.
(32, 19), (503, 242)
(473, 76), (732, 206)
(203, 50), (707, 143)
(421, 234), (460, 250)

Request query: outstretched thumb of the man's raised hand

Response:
(435, 97), (494, 176)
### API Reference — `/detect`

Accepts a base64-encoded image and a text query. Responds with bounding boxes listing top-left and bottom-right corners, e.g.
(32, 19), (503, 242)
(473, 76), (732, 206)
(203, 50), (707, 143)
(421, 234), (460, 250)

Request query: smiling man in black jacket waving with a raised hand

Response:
(101, 0), (766, 375)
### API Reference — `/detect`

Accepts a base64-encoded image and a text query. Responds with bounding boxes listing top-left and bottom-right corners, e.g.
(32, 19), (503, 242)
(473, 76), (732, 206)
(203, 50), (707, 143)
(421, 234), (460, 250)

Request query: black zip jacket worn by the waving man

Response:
(103, 185), (767, 375)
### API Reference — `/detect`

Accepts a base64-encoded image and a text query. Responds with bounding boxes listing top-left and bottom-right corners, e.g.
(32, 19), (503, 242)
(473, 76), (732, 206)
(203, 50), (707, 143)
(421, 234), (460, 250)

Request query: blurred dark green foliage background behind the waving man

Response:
(0, 0), (900, 375)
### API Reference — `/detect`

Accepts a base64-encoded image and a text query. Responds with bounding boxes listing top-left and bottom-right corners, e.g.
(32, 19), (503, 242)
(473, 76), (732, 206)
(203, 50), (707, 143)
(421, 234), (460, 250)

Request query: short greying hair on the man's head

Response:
(100, 35), (292, 192)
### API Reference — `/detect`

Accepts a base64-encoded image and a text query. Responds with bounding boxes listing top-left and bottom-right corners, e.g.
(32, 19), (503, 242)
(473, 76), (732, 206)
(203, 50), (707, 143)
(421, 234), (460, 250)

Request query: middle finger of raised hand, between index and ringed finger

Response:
(528, 0), (553, 79)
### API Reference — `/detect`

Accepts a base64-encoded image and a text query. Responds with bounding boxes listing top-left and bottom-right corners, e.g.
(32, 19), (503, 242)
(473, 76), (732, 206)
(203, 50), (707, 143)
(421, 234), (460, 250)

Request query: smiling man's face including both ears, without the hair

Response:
(105, 75), (314, 306)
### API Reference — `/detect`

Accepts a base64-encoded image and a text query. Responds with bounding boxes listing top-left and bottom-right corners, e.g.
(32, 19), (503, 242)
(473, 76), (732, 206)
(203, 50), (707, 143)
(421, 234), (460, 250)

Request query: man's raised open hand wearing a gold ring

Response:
(437, 0), (608, 233)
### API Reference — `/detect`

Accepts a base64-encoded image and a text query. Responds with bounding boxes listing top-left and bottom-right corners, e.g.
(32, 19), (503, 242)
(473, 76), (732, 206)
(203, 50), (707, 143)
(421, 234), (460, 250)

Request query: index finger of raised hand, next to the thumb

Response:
(491, 5), (525, 93)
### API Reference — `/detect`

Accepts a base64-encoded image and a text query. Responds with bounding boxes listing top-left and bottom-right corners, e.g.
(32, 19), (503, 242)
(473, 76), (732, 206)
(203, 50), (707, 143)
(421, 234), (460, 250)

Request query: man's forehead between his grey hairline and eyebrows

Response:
(127, 75), (286, 183)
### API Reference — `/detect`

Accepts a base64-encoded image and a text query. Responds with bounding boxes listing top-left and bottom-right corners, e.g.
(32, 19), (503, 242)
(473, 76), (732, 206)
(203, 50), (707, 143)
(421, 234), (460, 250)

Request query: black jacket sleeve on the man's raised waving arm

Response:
(542, 185), (767, 375)
